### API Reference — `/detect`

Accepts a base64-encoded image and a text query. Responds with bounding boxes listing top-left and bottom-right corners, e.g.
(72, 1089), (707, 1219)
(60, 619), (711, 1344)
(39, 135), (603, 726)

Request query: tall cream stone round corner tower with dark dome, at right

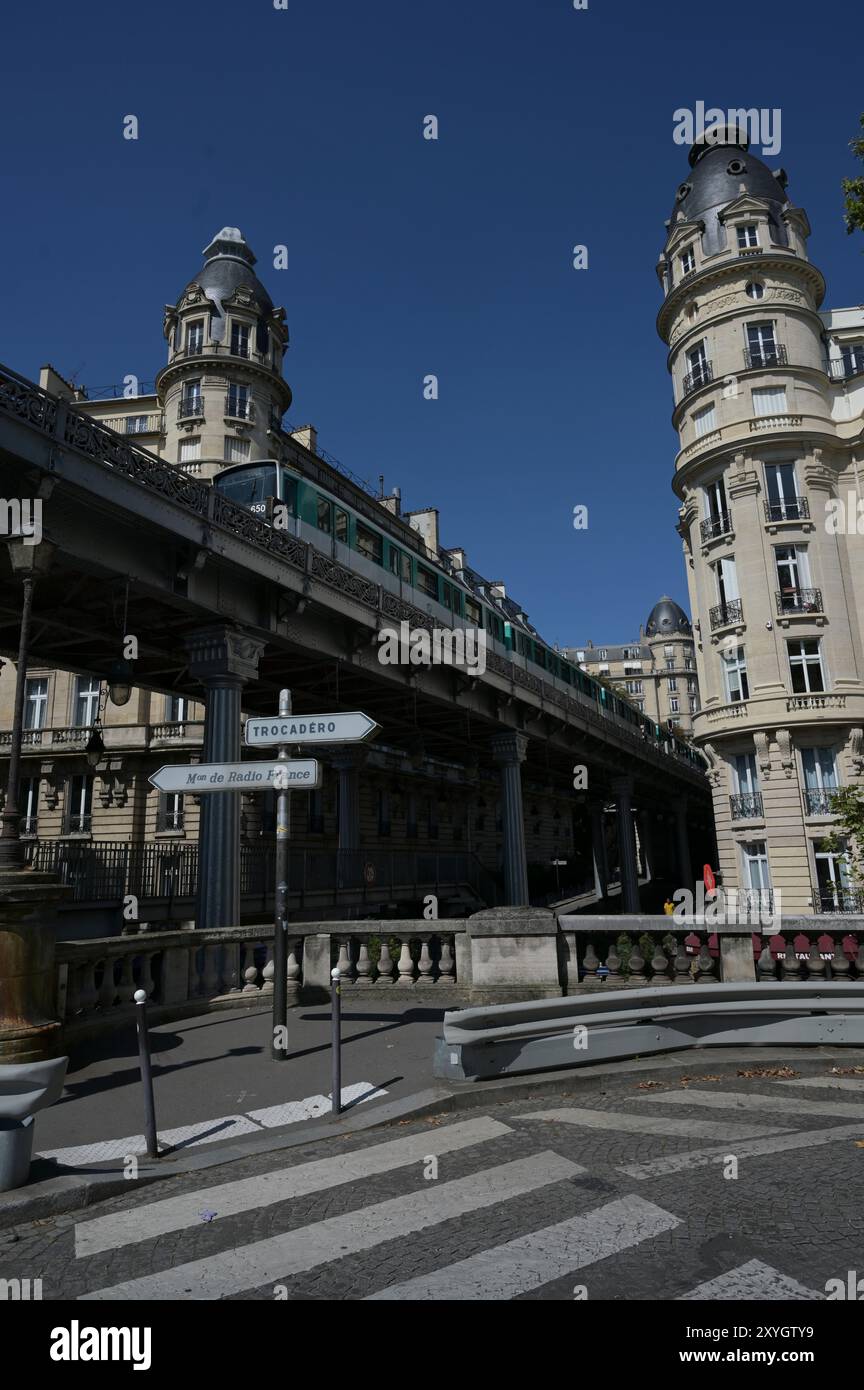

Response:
(657, 126), (864, 913)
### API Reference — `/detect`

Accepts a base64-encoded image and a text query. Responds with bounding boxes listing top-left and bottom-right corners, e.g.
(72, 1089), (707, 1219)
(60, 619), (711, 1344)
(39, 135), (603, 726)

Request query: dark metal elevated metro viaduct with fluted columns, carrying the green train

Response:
(0, 368), (711, 927)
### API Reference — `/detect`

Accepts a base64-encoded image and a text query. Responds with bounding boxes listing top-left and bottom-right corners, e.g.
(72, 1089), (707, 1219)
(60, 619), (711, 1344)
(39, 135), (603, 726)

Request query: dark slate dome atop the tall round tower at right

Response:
(670, 125), (789, 256)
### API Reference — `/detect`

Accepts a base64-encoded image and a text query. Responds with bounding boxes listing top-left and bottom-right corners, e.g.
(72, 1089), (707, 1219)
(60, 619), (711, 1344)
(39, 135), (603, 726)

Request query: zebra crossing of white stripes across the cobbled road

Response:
(65, 1079), (864, 1302)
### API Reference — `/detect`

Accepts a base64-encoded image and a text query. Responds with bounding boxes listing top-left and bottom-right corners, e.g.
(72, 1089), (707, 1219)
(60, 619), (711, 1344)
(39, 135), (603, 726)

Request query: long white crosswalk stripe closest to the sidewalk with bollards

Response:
(75, 1116), (513, 1258)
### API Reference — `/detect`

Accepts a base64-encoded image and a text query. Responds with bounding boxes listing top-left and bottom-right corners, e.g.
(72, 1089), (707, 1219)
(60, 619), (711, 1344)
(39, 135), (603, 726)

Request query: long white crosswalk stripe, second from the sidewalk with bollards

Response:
(81, 1136), (585, 1301)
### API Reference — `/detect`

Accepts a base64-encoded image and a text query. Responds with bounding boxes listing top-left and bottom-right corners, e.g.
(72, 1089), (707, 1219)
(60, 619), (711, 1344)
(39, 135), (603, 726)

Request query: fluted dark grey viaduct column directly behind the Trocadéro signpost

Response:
(186, 624), (264, 930)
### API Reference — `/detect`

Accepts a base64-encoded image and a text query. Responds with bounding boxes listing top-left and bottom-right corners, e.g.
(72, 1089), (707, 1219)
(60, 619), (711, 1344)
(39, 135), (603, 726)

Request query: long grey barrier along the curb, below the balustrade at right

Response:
(433, 980), (864, 1080)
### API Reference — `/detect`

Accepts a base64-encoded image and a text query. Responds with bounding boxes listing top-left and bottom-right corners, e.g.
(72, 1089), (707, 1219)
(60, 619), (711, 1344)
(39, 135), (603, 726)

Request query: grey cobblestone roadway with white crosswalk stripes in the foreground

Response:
(0, 1063), (864, 1301)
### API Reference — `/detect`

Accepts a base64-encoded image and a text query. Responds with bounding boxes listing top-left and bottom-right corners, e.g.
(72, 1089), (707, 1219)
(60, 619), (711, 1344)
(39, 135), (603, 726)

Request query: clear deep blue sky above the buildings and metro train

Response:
(0, 0), (864, 644)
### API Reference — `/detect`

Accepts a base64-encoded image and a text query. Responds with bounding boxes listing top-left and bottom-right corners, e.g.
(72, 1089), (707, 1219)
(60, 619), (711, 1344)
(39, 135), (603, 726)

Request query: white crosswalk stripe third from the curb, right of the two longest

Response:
(367, 1197), (681, 1302)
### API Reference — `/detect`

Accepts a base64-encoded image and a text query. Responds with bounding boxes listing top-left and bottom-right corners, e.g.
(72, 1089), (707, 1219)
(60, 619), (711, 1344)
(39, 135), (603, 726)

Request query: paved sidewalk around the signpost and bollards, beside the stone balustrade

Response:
(35, 999), (443, 1168)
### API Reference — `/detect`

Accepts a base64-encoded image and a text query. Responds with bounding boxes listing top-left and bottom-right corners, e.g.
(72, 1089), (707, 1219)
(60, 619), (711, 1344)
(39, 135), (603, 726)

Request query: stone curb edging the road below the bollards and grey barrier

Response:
(0, 1047), (864, 1232)
